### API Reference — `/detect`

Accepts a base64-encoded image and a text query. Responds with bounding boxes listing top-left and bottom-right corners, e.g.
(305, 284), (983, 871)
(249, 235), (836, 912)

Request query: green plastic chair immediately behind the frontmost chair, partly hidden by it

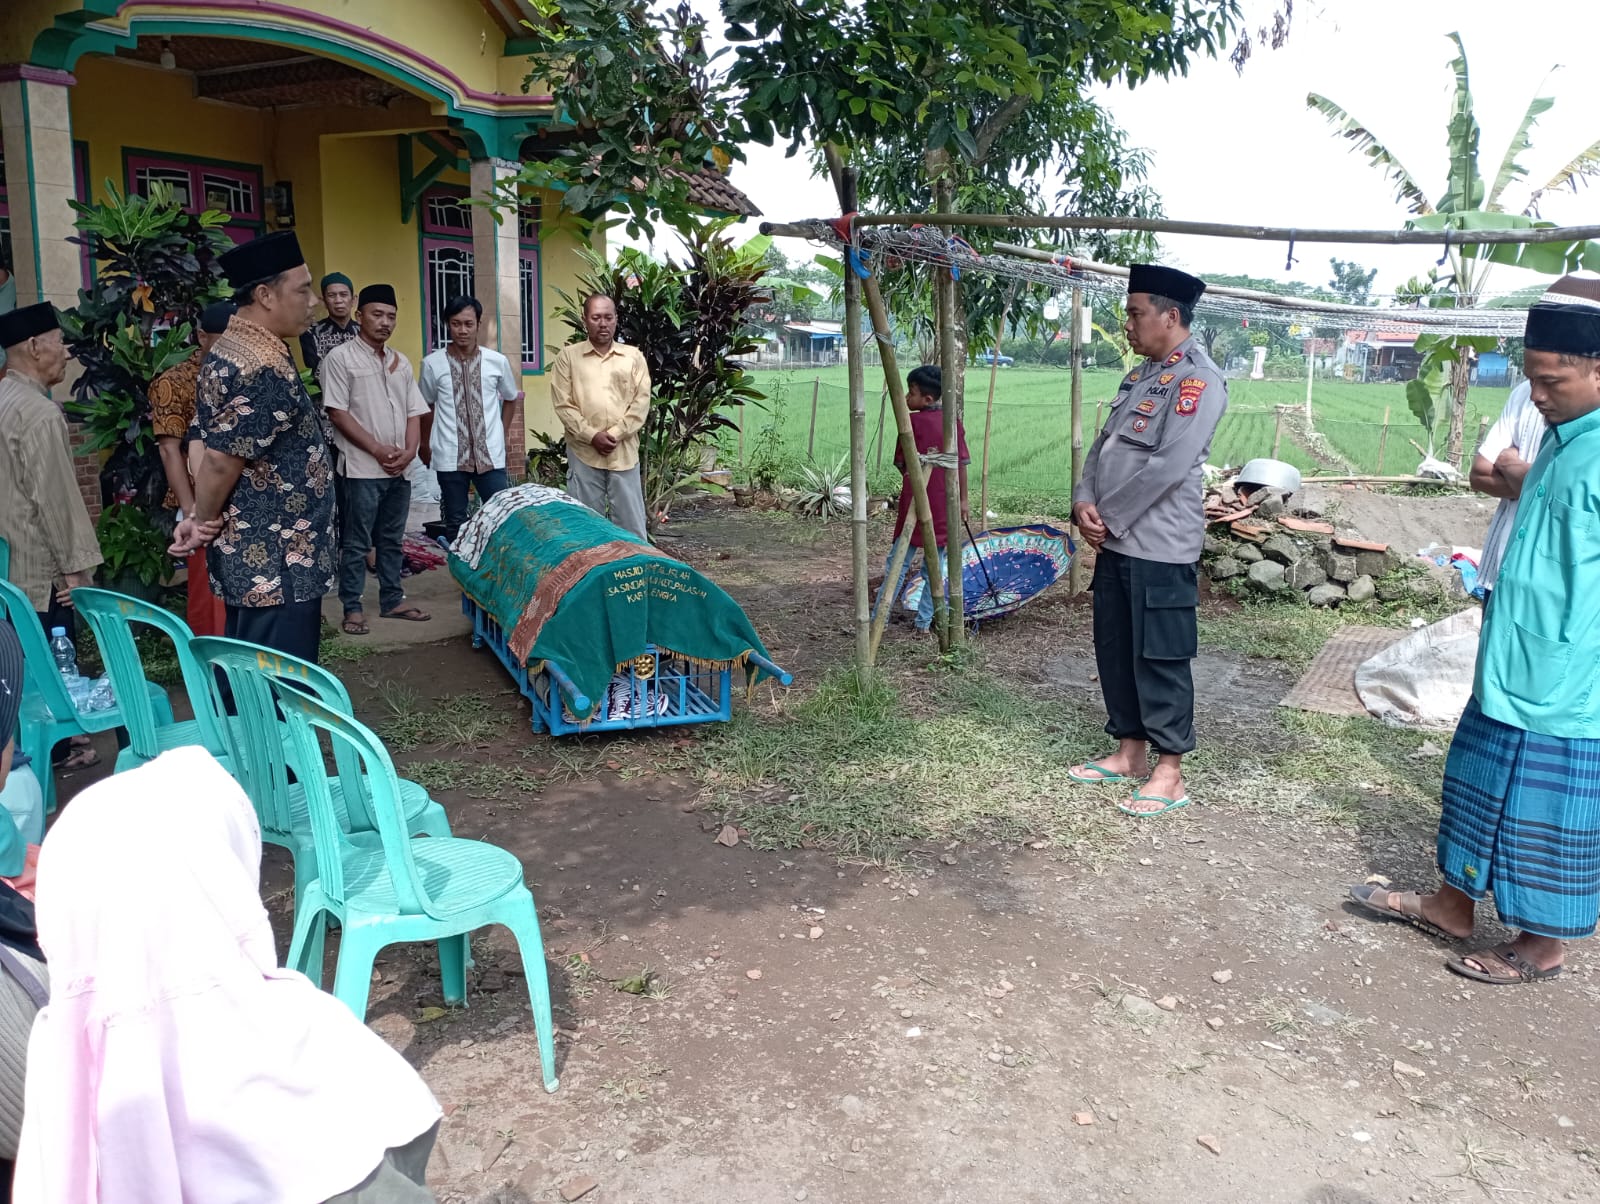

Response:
(189, 636), (450, 914)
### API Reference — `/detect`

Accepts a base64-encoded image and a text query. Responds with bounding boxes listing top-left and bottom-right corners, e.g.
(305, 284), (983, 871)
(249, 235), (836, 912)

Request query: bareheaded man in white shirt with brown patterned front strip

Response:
(421, 296), (522, 540)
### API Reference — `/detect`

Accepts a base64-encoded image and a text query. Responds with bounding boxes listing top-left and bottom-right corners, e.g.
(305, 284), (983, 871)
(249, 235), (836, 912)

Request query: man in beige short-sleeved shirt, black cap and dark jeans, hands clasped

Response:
(322, 285), (432, 636)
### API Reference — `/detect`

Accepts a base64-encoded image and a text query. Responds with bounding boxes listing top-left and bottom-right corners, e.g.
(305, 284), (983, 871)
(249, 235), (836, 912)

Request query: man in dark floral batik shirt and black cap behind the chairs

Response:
(171, 231), (334, 661)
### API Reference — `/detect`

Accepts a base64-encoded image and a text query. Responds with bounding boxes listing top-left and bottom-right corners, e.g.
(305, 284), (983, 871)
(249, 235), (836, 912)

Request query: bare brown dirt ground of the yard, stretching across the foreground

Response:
(59, 489), (1600, 1204)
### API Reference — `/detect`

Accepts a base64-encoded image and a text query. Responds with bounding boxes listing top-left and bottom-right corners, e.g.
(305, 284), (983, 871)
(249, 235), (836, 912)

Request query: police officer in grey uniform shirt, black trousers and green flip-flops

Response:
(1070, 264), (1227, 817)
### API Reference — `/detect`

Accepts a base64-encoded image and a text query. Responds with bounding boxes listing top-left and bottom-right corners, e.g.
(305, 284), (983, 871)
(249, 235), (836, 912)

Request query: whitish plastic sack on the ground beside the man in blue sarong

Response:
(1355, 607), (1483, 728)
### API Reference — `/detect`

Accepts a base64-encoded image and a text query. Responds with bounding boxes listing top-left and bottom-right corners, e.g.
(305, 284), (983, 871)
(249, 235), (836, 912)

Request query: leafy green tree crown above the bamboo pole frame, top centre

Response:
(723, 0), (1238, 410)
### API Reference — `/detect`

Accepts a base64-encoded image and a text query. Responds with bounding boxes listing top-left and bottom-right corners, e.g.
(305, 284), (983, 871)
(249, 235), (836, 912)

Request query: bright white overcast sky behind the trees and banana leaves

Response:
(696, 0), (1600, 299)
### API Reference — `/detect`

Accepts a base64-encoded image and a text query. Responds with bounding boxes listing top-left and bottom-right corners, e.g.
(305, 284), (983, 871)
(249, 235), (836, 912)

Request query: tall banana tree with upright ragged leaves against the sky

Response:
(1306, 34), (1600, 464)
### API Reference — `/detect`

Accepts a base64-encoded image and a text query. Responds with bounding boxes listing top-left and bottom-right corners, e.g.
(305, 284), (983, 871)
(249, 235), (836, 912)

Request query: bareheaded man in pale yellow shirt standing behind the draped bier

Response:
(550, 293), (650, 540)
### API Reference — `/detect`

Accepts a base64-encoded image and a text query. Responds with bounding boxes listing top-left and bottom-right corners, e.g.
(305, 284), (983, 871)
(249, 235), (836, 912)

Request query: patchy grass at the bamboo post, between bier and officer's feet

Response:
(701, 669), (1126, 861)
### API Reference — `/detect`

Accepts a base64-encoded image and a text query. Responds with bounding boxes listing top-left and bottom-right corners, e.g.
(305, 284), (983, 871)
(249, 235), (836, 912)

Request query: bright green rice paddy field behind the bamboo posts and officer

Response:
(723, 367), (1506, 512)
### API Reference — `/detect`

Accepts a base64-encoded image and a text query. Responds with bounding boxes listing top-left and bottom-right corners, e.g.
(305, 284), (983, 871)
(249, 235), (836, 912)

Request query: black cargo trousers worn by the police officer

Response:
(1093, 549), (1200, 754)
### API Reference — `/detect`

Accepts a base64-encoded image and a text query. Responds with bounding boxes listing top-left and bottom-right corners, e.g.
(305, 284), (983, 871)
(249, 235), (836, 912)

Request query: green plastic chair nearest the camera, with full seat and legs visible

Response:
(274, 682), (558, 1092)
